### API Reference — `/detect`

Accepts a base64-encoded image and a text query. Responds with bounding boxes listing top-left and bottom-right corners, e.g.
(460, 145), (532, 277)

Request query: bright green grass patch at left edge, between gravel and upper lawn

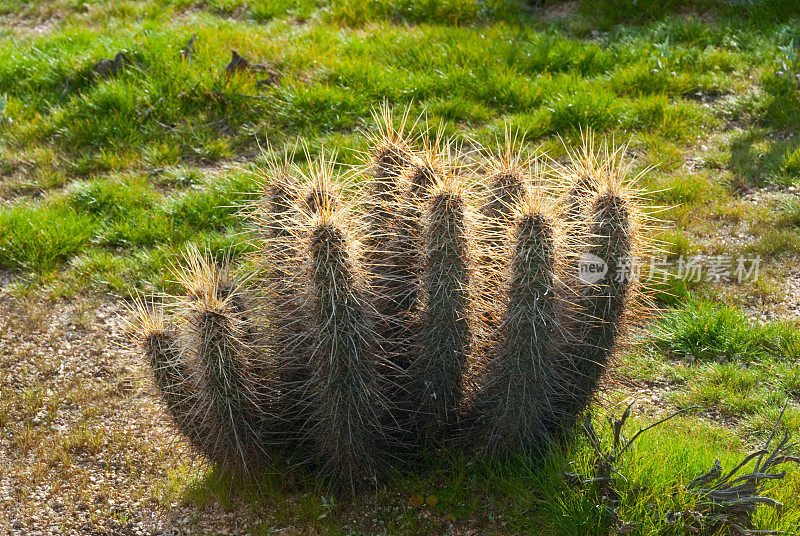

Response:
(0, 173), (255, 294)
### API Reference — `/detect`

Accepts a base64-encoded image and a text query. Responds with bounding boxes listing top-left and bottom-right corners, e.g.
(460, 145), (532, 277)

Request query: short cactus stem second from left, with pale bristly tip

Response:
(179, 255), (269, 472)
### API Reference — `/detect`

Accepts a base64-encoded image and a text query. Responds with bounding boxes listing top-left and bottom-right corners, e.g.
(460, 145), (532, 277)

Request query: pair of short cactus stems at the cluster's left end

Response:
(132, 250), (271, 473)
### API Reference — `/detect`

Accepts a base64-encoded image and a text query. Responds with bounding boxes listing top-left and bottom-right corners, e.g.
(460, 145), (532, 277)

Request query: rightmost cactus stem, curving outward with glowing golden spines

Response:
(543, 139), (649, 441)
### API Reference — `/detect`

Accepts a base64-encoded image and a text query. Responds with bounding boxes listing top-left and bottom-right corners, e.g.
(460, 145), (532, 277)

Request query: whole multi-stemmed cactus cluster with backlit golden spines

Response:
(131, 109), (641, 491)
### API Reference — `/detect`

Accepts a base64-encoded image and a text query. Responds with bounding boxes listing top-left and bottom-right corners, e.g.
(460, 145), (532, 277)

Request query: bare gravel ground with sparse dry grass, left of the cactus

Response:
(0, 293), (256, 535)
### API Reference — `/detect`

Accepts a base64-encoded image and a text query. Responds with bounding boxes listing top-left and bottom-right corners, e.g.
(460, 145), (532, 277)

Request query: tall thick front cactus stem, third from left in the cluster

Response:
(299, 153), (385, 490)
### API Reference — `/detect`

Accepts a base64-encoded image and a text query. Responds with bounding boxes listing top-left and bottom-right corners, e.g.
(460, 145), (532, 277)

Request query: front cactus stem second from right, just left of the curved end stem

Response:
(476, 195), (563, 453)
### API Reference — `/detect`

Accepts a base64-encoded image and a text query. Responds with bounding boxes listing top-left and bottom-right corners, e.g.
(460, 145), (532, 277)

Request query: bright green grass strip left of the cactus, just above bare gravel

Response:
(0, 174), (254, 284)
